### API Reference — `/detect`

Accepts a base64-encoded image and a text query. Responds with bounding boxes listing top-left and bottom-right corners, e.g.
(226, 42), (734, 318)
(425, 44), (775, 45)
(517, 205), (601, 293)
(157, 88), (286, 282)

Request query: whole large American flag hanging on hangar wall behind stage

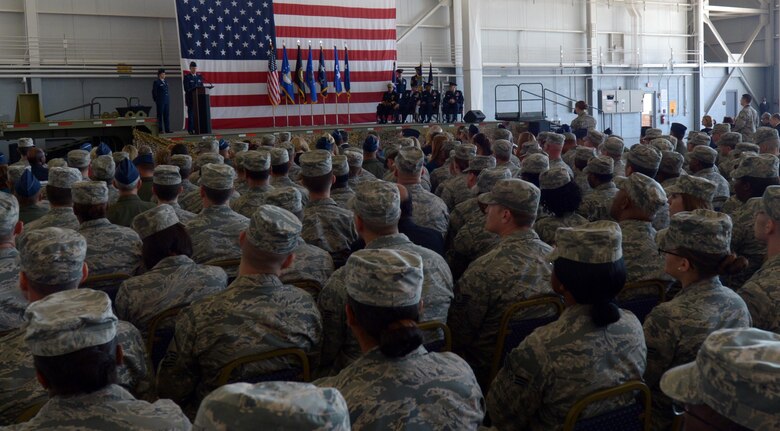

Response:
(176, 0), (396, 129)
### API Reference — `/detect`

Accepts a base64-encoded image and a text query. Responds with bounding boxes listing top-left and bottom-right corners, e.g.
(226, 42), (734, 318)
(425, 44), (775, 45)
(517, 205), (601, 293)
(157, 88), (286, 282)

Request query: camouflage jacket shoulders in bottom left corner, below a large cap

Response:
(3, 385), (192, 431)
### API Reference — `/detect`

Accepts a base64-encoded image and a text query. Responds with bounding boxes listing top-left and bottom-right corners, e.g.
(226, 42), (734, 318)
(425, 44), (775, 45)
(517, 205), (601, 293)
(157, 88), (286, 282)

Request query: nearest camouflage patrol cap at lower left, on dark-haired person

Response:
(24, 290), (119, 357)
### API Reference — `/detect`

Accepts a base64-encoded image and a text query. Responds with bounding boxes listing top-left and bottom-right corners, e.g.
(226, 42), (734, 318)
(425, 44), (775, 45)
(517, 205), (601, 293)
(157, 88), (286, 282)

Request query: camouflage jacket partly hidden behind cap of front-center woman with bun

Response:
(317, 233), (453, 372)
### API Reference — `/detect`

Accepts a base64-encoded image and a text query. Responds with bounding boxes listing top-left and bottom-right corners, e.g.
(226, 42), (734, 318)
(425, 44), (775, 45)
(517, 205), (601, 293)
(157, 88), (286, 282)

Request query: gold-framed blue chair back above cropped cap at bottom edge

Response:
(217, 349), (311, 386)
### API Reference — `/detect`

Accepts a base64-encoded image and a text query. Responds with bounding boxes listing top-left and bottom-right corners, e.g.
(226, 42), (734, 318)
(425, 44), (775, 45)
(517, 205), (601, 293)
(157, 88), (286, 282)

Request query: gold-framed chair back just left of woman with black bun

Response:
(490, 294), (563, 381)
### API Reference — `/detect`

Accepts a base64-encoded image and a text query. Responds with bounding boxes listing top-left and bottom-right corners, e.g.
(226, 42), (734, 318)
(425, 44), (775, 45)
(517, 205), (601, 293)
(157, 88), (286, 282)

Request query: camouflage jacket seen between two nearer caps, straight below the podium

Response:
(184, 205), (249, 263)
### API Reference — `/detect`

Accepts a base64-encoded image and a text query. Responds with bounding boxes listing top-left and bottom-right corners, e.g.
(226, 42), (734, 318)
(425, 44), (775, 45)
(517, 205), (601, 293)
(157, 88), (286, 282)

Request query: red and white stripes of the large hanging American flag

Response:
(182, 0), (396, 129)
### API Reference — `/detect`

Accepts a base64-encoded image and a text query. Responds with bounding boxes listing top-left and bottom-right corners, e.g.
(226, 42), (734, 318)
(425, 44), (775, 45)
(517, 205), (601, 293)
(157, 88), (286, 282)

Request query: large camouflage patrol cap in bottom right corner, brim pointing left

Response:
(661, 328), (780, 430)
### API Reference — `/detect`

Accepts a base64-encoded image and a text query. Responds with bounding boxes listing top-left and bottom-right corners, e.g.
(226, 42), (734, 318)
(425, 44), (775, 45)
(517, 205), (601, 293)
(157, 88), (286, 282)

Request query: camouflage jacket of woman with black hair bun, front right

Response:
(487, 305), (647, 431)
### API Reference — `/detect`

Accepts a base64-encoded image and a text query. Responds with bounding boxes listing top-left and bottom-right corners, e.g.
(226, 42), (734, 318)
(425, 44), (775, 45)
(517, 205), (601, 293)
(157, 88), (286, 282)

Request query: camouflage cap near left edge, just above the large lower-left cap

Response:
(20, 226), (86, 286)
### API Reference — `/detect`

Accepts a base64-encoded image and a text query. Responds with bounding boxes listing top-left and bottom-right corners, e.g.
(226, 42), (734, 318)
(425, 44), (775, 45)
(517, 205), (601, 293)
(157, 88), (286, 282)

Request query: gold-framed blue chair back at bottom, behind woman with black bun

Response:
(563, 380), (651, 431)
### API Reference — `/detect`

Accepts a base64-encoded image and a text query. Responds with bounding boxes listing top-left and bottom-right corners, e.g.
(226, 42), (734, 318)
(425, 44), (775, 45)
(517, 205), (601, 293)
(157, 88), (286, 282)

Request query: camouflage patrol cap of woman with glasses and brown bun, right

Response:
(655, 209), (731, 255)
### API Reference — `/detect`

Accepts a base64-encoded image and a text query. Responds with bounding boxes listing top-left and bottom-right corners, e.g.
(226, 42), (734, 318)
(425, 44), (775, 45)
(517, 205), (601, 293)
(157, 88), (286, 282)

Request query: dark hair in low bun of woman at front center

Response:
(348, 297), (423, 358)
